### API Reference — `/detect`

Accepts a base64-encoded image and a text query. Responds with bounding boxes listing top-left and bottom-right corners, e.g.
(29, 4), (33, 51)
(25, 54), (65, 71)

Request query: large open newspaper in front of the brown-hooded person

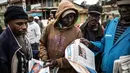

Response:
(65, 39), (96, 73)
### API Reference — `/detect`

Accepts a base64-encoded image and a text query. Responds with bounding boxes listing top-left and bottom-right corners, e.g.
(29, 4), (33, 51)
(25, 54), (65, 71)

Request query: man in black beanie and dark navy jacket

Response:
(0, 6), (32, 73)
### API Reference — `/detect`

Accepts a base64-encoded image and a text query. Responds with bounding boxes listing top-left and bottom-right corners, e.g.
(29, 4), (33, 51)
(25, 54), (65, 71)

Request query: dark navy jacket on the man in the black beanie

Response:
(0, 27), (32, 73)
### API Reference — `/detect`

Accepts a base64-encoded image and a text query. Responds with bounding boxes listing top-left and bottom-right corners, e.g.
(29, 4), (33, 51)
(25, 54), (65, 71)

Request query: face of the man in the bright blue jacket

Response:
(118, 5), (130, 22)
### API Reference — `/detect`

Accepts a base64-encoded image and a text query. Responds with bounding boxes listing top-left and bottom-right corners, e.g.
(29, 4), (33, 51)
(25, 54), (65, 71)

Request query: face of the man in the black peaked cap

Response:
(88, 13), (100, 31)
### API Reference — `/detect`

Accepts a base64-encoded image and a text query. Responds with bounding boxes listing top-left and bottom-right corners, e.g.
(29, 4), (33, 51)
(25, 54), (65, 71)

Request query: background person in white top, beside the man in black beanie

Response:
(27, 16), (41, 59)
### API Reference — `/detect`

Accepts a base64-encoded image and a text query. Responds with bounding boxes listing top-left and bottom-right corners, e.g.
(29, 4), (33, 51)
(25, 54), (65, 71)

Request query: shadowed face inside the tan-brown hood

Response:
(61, 13), (75, 27)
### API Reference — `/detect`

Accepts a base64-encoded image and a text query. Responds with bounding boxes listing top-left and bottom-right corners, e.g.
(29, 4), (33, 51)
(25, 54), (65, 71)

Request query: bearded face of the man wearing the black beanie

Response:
(9, 19), (28, 36)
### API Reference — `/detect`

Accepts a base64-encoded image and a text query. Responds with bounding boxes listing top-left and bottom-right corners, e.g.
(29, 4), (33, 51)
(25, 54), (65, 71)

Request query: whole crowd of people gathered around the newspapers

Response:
(0, 0), (130, 73)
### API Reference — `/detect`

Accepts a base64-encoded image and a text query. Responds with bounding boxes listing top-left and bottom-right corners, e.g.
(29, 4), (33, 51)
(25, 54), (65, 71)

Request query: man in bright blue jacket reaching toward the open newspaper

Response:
(82, 0), (130, 73)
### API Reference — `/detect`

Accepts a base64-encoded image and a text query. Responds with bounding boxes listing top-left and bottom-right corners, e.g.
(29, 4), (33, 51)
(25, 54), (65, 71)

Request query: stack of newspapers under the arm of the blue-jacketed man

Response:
(113, 55), (130, 73)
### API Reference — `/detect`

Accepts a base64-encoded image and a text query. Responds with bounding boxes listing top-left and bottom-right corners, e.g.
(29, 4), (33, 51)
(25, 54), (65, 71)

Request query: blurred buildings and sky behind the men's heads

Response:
(0, 0), (119, 28)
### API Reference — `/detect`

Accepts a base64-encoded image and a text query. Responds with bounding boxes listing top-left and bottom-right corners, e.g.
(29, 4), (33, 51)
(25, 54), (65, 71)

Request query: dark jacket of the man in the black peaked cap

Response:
(80, 21), (104, 73)
